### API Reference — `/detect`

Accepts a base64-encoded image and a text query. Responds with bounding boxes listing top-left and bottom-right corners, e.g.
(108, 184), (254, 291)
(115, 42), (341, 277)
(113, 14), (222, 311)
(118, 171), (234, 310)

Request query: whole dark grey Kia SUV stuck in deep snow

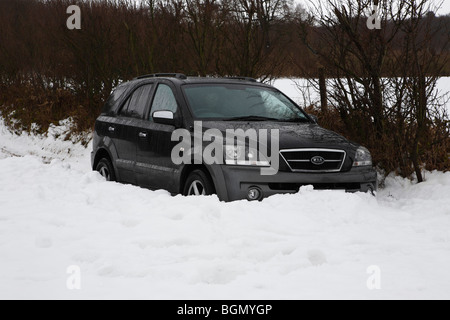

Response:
(92, 74), (377, 201)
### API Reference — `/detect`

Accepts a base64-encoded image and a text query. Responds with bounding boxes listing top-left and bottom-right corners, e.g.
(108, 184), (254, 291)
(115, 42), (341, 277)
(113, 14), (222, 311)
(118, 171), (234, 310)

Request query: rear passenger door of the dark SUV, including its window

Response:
(109, 83), (153, 184)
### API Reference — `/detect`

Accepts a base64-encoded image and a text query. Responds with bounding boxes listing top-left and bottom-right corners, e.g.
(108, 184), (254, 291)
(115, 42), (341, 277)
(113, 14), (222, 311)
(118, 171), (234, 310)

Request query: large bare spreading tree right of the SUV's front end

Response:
(299, 0), (446, 182)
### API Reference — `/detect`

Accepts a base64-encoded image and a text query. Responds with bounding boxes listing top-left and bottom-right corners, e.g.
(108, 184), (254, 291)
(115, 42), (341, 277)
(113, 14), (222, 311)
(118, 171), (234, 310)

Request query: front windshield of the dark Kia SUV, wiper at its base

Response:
(183, 84), (310, 122)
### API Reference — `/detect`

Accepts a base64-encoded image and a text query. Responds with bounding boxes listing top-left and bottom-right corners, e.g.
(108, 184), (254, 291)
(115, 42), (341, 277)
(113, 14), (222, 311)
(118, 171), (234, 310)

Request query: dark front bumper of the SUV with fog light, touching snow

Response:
(211, 165), (378, 201)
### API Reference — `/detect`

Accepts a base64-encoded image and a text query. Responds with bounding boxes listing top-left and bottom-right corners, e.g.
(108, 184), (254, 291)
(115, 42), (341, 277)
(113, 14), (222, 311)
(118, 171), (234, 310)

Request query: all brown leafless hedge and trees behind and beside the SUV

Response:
(0, 0), (450, 176)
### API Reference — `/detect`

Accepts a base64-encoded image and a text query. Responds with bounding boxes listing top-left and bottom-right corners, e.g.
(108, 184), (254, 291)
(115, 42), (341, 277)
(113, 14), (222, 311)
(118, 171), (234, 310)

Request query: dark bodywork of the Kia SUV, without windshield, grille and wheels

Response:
(92, 77), (377, 201)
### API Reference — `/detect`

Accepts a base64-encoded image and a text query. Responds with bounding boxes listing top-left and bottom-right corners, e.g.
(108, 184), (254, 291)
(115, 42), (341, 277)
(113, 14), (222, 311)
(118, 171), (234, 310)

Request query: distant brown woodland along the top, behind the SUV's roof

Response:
(0, 0), (450, 90)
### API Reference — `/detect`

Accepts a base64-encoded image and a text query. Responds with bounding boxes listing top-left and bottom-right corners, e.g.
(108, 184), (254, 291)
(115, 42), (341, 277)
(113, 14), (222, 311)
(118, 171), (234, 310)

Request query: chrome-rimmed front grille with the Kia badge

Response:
(280, 149), (346, 173)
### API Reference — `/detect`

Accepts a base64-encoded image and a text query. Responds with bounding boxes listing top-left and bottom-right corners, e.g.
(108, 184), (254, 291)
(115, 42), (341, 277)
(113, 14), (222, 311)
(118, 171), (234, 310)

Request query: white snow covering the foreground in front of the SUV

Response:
(0, 80), (450, 299)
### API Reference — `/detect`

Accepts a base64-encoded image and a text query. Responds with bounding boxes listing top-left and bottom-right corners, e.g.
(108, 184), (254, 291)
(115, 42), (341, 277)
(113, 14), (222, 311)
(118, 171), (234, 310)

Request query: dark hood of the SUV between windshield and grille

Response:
(202, 121), (358, 153)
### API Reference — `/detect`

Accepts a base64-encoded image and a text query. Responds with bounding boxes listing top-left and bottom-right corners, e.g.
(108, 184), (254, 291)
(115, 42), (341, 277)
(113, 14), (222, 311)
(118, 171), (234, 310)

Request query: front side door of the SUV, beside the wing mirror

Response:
(136, 82), (181, 193)
